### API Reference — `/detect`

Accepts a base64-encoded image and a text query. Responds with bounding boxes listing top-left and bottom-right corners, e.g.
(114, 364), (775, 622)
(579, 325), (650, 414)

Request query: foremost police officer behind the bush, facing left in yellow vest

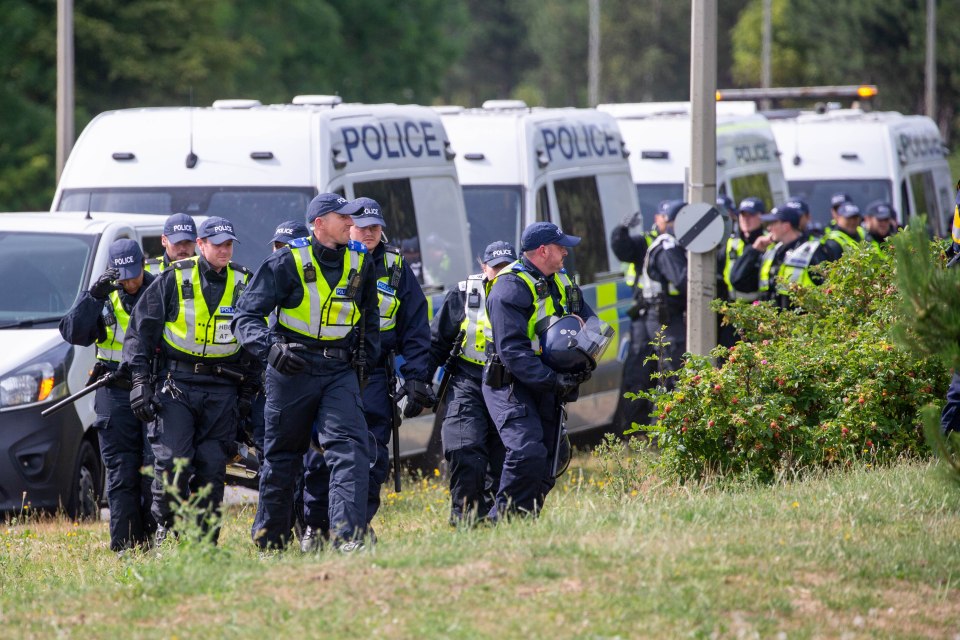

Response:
(731, 200), (830, 309)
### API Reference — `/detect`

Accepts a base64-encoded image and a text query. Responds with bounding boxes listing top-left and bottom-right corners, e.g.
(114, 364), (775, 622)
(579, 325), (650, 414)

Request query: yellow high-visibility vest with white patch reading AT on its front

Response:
(163, 257), (246, 358)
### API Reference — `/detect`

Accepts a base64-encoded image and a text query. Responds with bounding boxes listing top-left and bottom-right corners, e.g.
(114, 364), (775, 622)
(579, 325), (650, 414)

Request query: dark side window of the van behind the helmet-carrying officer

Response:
(553, 176), (610, 284)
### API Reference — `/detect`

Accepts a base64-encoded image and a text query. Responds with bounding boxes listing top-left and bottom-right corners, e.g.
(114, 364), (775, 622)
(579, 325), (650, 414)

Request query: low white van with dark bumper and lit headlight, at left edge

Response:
(0, 212), (165, 518)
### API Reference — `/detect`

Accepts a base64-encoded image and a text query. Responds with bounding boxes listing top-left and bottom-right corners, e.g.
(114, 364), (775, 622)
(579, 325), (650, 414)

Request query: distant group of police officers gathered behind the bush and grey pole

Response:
(610, 193), (896, 426)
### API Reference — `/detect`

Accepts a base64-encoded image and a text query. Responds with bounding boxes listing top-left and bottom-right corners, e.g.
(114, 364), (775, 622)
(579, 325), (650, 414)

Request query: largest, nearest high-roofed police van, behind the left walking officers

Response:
(52, 95), (475, 464)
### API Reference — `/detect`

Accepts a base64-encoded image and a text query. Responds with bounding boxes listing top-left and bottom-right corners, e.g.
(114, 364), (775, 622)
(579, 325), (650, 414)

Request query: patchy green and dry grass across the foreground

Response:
(0, 458), (960, 639)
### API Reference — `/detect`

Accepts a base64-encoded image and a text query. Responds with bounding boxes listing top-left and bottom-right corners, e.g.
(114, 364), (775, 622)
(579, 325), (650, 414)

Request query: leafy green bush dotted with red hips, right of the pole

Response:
(636, 242), (947, 481)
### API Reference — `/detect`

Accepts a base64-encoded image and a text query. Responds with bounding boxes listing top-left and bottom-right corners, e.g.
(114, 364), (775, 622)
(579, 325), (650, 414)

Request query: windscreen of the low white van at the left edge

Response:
(0, 231), (95, 325)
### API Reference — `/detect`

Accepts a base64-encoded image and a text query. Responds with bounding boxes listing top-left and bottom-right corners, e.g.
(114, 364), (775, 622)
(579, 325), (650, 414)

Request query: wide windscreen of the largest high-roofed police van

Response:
(57, 187), (317, 270)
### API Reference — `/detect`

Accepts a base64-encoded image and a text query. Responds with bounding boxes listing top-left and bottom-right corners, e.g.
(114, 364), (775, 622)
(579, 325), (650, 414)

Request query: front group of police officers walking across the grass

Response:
(60, 193), (610, 553)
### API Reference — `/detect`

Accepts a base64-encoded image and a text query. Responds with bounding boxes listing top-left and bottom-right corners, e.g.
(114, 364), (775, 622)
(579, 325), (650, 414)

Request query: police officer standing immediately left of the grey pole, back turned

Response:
(640, 200), (687, 396)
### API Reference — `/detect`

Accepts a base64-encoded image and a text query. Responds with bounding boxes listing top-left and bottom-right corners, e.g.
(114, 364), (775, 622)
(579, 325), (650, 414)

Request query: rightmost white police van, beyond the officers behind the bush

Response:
(769, 108), (954, 236)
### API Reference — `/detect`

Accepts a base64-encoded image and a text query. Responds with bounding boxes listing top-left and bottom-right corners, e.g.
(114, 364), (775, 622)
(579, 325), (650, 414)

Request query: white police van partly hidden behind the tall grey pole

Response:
(597, 102), (789, 229)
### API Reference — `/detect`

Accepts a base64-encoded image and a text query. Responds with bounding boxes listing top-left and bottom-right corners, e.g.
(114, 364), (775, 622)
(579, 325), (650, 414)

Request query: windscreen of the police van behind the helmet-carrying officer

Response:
(463, 186), (523, 259)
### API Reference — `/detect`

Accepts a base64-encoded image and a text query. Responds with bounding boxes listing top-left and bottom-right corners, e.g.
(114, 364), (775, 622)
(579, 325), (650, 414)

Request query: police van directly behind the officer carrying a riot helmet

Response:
(436, 100), (639, 433)
